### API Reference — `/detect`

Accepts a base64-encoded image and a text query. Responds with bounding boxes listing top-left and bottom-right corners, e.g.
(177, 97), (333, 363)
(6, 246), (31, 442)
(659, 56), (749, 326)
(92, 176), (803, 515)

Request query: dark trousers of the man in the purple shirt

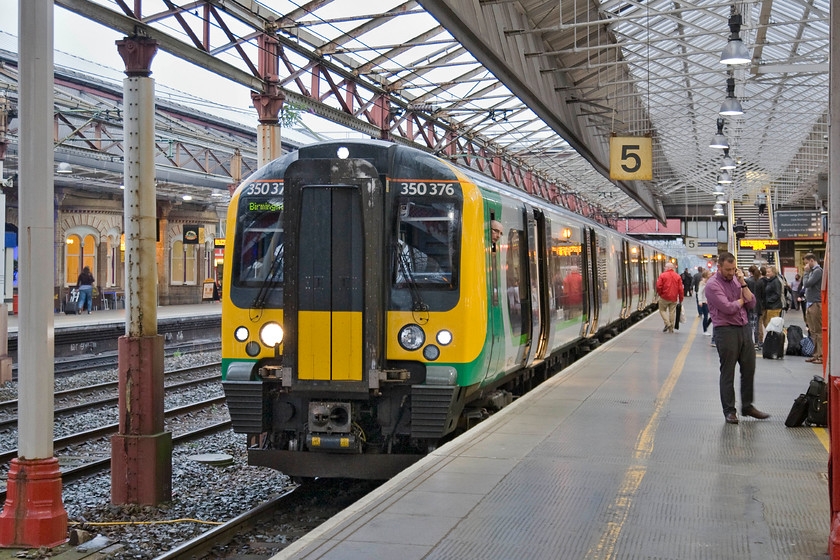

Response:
(714, 323), (755, 414)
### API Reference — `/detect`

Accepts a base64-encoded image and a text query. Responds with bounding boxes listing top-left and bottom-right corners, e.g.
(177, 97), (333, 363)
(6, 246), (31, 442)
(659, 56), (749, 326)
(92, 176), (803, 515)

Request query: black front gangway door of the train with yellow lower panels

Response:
(283, 159), (386, 390)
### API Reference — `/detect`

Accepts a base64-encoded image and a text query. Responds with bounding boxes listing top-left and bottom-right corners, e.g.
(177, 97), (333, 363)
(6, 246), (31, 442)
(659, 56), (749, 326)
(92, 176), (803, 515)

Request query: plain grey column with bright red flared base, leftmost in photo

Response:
(0, 0), (67, 548)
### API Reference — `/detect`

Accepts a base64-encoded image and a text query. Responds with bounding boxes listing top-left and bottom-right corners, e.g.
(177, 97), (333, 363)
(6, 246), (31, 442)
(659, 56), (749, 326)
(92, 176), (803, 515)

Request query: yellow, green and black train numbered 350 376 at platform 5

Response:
(222, 140), (673, 479)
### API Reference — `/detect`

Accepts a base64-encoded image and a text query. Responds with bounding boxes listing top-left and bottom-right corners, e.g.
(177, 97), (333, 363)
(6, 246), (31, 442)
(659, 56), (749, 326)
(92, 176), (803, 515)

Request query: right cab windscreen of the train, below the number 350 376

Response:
(392, 199), (461, 290)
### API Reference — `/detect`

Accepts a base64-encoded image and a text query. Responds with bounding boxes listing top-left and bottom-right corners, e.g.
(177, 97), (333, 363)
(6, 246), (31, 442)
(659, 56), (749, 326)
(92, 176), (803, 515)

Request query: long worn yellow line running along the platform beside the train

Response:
(586, 317), (700, 560)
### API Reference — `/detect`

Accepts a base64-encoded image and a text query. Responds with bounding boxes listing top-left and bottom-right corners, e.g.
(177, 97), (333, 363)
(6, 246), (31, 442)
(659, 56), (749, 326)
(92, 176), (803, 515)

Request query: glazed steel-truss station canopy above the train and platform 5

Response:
(44, 0), (829, 219)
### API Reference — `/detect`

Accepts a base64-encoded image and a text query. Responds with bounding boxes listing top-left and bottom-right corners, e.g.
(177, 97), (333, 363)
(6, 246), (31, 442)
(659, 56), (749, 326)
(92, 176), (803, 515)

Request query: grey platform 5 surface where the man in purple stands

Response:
(273, 305), (830, 560)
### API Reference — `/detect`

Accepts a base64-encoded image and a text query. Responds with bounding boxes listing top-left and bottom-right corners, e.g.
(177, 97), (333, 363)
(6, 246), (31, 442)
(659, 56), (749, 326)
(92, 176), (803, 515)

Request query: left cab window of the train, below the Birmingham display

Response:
(232, 190), (283, 302)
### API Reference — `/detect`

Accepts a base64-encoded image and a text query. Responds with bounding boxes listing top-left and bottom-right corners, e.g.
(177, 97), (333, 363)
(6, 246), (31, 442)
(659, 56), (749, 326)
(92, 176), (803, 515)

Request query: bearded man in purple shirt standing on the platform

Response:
(705, 253), (770, 424)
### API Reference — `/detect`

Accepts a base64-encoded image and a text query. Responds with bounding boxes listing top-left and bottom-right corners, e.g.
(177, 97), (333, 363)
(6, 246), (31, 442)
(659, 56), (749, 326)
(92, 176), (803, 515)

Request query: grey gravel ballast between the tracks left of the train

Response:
(0, 352), (296, 560)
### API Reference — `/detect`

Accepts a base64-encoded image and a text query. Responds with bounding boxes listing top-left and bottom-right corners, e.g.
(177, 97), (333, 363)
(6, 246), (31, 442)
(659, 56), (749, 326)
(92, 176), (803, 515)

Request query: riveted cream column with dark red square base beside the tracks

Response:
(111, 36), (172, 505)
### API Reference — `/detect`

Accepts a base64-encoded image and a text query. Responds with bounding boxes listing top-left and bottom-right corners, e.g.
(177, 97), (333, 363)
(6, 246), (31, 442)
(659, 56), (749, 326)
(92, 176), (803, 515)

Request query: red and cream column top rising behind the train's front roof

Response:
(251, 35), (286, 167)
